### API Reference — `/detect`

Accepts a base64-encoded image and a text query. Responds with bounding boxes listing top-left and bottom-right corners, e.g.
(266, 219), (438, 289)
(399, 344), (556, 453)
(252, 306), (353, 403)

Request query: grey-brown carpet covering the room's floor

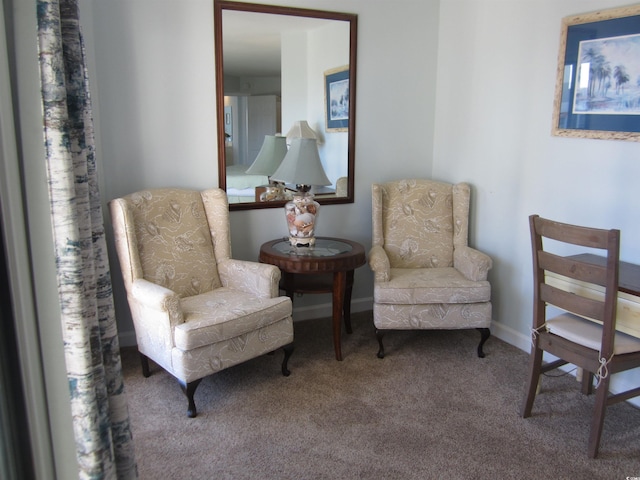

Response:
(122, 312), (640, 480)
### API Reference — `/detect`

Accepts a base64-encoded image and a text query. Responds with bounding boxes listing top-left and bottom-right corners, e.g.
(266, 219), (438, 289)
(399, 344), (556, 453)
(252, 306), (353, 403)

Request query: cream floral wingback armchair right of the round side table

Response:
(369, 179), (492, 358)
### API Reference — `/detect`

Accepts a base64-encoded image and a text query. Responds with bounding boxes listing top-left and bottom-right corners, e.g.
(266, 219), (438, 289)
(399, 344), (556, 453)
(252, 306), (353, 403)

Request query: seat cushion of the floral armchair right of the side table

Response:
(373, 267), (491, 305)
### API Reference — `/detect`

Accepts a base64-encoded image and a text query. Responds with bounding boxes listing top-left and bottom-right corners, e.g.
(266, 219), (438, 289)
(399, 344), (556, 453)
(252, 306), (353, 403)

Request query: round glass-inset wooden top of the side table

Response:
(259, 237), (366, 273)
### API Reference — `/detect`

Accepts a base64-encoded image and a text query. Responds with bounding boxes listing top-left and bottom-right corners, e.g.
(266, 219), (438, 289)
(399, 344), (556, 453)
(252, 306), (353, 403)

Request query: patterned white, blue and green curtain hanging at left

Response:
(37, 0), (137, 479)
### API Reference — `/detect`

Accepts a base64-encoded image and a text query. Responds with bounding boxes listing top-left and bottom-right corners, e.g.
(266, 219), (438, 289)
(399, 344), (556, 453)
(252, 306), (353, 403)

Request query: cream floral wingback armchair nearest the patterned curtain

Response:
(109, 189), (293, 417)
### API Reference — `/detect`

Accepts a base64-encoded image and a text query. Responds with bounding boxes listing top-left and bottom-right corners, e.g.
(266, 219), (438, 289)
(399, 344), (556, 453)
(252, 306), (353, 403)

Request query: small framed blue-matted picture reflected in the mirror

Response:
(324, 66), (349, 132)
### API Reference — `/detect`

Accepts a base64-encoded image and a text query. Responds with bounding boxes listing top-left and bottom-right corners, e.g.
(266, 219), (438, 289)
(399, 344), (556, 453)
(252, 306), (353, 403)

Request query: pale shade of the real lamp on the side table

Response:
(271, 138), (331, 190)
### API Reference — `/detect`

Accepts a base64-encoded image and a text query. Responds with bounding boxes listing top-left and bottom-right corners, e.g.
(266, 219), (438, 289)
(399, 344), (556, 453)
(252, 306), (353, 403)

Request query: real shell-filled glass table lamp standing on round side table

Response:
(272, 138), (331, 247)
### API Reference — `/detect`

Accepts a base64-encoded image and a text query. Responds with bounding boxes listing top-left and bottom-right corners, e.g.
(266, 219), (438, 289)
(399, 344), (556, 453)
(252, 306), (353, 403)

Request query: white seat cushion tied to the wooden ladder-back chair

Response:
(547, 313), (640, 355)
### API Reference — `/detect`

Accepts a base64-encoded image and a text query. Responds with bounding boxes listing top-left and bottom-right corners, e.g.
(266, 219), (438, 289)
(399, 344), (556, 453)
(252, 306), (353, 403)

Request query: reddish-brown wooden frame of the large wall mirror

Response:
(213, 0), (358, 210)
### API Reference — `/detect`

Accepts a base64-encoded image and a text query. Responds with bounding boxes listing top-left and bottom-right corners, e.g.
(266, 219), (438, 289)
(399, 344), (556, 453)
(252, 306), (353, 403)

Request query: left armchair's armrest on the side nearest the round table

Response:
(218, 259), (281, 298)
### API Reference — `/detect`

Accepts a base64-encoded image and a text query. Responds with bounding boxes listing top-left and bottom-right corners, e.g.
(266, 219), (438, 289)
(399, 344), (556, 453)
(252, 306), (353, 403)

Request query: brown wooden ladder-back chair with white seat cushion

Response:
(521, 215), (640, 458)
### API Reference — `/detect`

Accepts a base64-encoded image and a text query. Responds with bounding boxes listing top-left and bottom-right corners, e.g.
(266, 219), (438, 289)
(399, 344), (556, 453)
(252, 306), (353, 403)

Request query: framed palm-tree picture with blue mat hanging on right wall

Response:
(552, 5), (640, 142)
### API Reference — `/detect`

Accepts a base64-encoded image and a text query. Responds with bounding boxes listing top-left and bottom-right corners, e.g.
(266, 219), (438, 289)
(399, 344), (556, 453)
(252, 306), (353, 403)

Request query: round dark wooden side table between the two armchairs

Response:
(259, 237), (366, 360)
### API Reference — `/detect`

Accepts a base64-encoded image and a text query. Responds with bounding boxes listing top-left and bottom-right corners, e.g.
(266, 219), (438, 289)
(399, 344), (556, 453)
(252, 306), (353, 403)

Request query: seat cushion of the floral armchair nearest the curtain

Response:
(174, 287), (291, 350)
